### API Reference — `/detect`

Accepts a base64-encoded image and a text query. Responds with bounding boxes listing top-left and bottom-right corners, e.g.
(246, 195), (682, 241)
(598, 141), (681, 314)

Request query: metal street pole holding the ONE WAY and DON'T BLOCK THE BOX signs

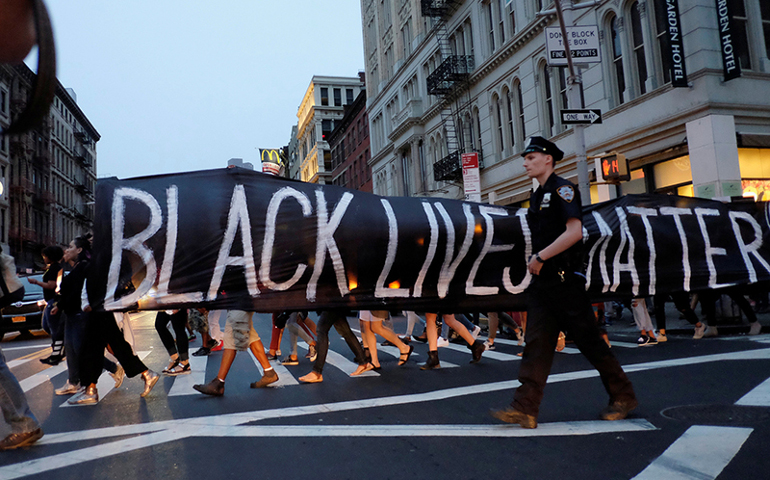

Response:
(554, 0), (591, 205)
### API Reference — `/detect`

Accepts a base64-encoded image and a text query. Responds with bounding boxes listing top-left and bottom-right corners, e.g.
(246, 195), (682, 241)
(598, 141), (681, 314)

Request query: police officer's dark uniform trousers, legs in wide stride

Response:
(512, 274), (635, 417)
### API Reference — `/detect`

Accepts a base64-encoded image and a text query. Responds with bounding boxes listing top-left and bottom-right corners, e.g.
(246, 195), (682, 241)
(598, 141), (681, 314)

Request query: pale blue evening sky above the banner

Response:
(27, 0), (364, 178)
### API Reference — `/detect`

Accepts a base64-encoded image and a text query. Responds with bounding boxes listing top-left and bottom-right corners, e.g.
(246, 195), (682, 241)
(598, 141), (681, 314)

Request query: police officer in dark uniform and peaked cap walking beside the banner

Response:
(491, 137), (638, 428)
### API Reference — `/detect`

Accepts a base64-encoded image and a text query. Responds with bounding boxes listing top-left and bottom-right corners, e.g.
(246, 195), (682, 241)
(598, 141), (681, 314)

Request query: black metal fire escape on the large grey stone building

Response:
(421, 0), (483, 182)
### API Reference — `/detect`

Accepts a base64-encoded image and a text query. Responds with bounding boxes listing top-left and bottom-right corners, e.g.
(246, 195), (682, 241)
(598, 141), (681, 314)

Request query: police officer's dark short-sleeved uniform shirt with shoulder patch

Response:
(527, 173), (583, 280)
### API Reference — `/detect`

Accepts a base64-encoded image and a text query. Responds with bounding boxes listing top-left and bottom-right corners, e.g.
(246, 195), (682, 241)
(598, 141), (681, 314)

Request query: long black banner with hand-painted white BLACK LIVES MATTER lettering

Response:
(88, 168), (770, 312)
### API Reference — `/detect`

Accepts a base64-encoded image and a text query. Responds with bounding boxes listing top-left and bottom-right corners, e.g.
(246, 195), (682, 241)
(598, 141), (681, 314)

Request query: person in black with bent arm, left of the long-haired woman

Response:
(28, 245), (64, 365)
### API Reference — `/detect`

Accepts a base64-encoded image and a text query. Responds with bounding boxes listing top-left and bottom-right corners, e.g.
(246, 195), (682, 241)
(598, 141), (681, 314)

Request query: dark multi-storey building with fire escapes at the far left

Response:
(0, 64), (100, 269)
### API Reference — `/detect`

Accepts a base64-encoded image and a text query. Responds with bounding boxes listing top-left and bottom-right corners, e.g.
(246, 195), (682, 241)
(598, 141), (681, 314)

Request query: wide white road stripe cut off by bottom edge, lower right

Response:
(634, 425), (753, 480)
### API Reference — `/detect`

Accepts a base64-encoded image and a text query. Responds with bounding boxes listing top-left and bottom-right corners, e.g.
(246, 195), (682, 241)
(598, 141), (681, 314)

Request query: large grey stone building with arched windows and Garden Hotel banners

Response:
(361, 0), (770, 205)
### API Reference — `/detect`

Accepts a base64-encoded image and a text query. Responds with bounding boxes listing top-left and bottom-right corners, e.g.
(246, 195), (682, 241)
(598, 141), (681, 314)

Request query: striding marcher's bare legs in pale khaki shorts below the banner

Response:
(193, 310), (278, 396)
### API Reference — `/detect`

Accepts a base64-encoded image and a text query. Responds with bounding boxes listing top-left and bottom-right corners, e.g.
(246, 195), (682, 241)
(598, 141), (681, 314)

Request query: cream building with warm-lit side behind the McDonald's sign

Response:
(296, 75), (364, 184)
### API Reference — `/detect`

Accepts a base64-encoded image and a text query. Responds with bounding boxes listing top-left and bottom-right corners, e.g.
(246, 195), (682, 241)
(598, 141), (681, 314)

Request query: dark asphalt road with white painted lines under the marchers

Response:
(0, 313), (770, 480)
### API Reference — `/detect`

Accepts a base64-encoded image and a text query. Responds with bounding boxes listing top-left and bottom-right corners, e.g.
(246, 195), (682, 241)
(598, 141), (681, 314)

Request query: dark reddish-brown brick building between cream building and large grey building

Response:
(329, 90), (372, 193)
